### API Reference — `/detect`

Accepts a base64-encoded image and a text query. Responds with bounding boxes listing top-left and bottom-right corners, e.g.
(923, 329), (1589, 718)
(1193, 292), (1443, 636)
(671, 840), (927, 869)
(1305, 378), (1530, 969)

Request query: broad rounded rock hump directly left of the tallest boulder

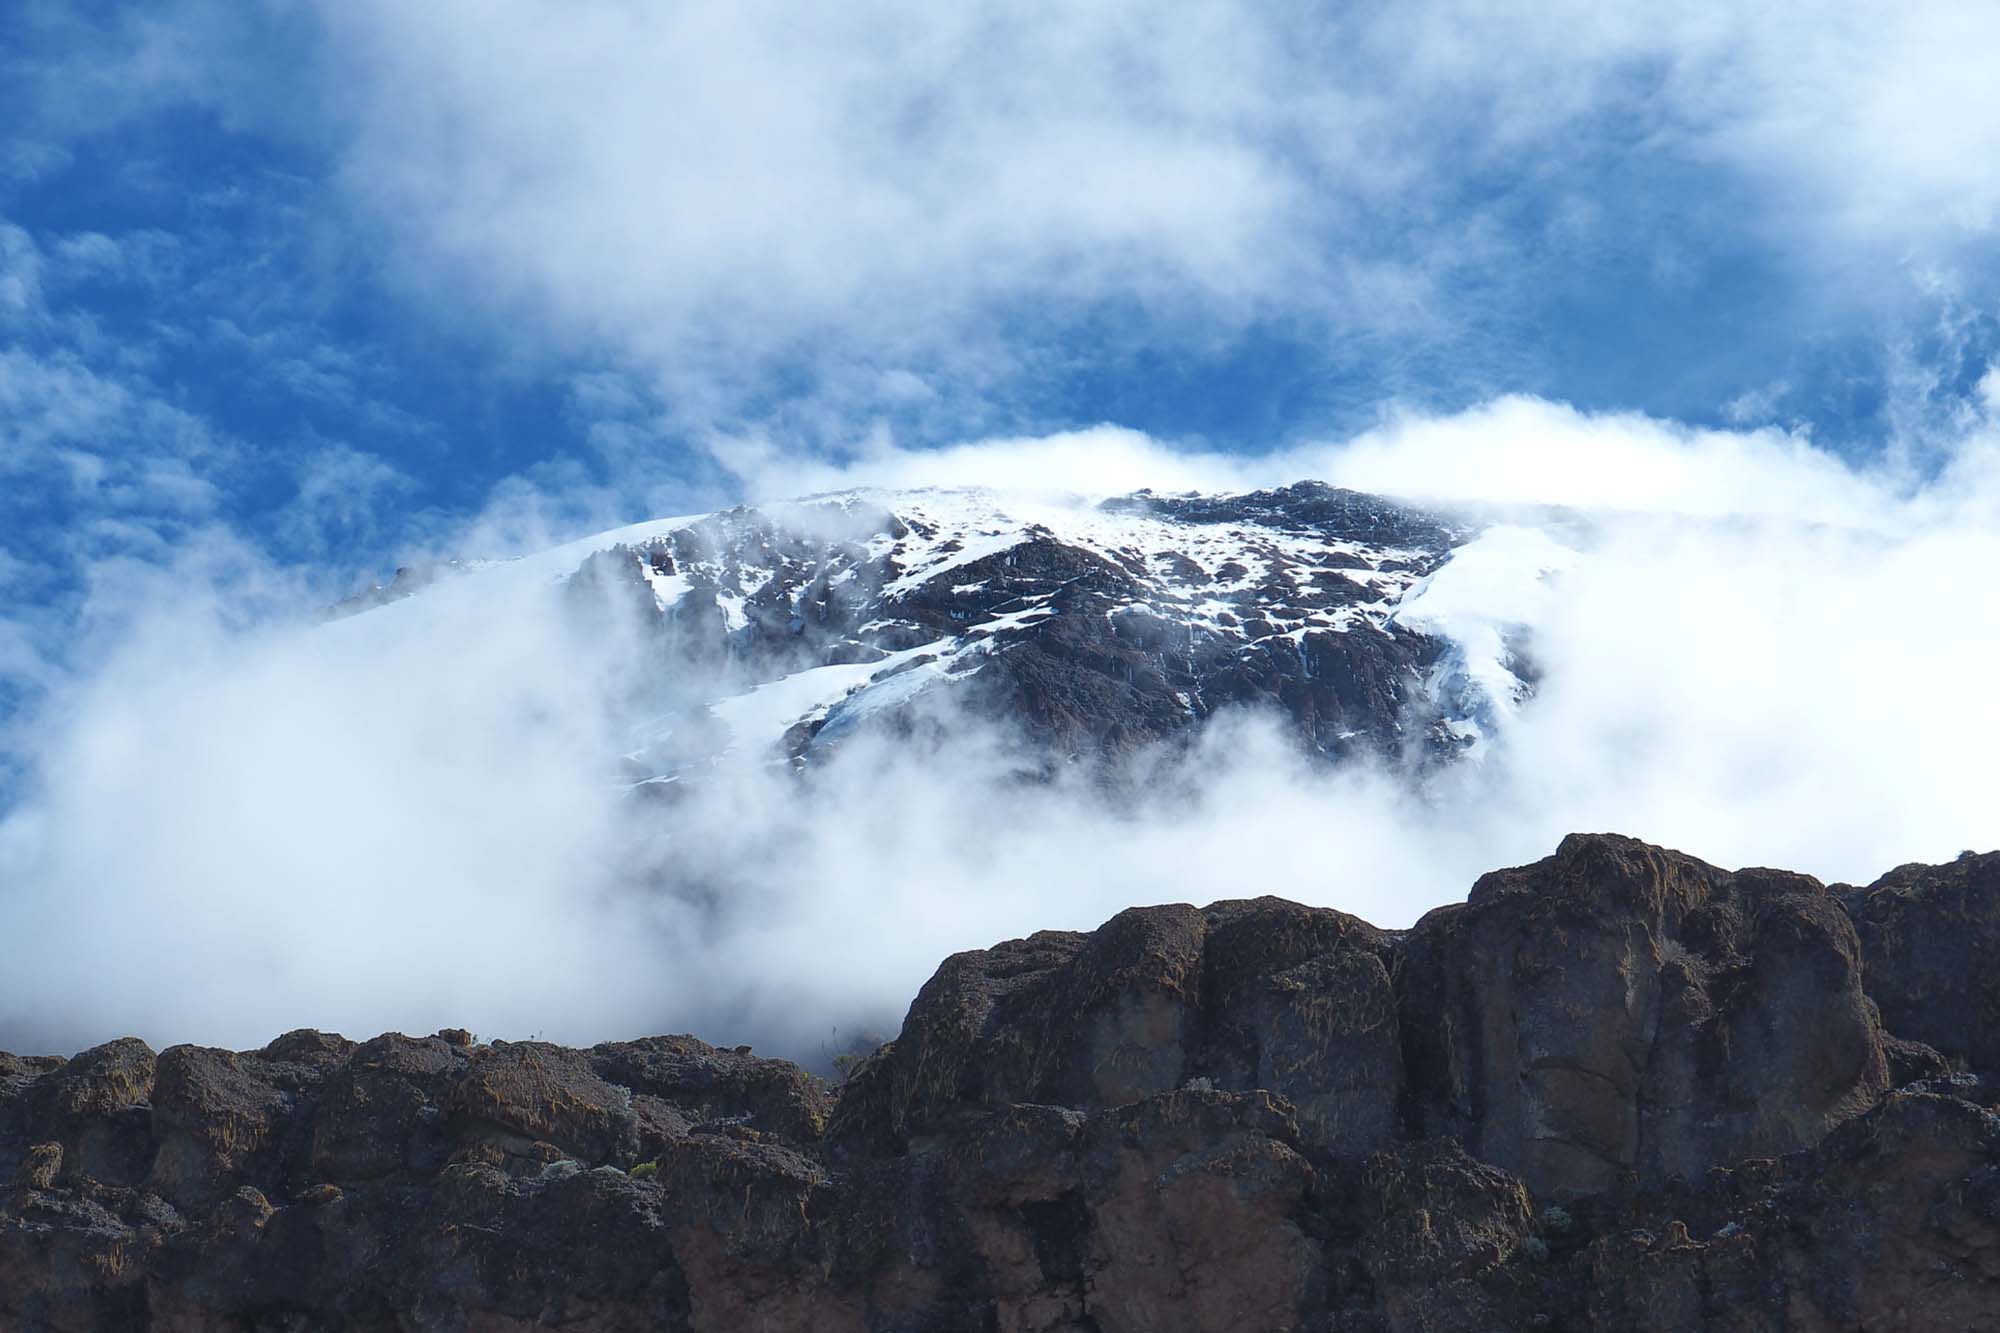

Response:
(854, 899), (1402, 1153)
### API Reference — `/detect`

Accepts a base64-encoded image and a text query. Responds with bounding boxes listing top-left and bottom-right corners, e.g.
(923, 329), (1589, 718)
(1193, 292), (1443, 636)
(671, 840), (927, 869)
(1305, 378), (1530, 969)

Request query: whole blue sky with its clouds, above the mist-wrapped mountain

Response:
(11, 0), (2000, 756)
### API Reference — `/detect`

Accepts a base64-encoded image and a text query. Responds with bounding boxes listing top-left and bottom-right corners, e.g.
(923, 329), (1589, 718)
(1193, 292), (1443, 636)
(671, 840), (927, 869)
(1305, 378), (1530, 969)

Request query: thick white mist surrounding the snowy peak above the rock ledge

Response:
(0, 398), (2000, 1061)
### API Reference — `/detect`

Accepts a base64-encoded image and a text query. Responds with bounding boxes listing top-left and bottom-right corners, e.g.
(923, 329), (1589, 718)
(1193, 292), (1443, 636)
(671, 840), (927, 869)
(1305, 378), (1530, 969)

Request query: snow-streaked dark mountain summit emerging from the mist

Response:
(344, 482), (1548, 785)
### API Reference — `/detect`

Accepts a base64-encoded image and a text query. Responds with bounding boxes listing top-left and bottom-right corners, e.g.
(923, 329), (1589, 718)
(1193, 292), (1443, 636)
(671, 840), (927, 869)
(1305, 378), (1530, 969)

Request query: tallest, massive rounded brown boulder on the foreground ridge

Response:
(1400, 837), (1890, 1195)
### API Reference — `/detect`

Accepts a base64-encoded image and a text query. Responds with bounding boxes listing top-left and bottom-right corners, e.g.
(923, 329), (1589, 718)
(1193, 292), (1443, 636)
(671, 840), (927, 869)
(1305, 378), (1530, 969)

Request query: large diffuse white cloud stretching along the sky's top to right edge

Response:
(254, 0), (2000, 436)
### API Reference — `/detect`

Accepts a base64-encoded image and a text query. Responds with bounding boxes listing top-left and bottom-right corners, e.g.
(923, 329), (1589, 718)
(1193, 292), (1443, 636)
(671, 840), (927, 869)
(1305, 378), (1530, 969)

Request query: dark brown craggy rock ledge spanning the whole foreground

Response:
(0, 837), (2000, 1333)
